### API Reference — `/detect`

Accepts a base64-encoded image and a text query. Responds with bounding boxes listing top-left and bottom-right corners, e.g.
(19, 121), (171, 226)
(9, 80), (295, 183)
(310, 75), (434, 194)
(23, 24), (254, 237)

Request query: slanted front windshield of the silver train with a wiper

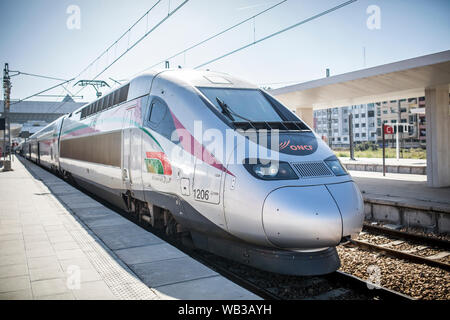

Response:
(198, 88), (283, 122)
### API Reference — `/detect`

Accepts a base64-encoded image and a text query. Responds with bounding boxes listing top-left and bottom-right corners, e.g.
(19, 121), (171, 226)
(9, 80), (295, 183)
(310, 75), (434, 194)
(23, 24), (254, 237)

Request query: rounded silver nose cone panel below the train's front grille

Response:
(263, 185), (342, 249)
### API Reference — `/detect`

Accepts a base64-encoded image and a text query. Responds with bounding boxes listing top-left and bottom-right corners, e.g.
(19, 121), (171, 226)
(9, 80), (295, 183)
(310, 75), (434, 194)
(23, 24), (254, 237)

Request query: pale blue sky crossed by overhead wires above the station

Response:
(0, 0), (450, 101)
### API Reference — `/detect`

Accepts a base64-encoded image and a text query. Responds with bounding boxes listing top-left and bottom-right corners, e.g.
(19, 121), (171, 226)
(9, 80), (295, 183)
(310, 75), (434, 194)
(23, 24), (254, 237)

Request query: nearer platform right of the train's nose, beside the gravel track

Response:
(350, 170), (450, 234)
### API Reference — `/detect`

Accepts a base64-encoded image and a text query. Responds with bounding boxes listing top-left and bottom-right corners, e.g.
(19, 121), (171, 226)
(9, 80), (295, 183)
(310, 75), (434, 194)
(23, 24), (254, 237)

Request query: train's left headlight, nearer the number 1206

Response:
(244, 159), (298, 180)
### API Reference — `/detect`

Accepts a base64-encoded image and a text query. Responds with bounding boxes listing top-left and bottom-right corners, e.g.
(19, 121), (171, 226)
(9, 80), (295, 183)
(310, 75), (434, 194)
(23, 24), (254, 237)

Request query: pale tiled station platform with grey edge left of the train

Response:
(0, 157), (260, 300)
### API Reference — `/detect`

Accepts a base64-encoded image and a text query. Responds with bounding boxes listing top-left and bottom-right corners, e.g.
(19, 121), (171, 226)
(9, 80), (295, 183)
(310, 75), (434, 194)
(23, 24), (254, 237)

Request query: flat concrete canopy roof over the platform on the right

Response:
(269, 50), (450, 109)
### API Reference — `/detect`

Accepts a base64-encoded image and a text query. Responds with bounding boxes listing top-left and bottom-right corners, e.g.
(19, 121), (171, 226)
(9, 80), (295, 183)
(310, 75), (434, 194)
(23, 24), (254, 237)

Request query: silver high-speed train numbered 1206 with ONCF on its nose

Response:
(20, 69), (364, 275)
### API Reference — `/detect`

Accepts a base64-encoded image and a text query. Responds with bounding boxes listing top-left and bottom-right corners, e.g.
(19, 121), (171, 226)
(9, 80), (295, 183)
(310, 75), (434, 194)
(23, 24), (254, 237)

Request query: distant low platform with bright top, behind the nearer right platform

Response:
(339, 157), (427, 175)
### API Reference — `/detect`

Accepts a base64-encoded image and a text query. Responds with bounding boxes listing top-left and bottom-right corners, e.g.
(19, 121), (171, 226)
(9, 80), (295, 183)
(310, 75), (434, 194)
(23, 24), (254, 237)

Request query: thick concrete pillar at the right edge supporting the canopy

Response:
(425, 85), (450, 187)
